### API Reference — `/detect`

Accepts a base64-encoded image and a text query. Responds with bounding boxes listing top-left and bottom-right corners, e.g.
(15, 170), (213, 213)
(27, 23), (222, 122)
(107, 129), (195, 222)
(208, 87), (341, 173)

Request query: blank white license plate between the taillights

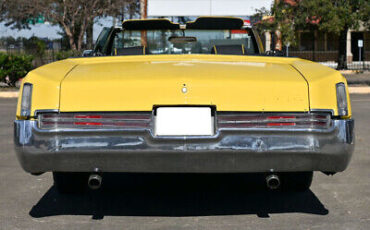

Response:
(154, 107), (214, 136)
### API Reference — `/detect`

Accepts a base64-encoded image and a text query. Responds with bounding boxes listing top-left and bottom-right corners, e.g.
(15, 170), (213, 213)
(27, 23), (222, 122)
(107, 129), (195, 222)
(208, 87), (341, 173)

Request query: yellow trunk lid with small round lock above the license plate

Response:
(60, 55), (309, 112)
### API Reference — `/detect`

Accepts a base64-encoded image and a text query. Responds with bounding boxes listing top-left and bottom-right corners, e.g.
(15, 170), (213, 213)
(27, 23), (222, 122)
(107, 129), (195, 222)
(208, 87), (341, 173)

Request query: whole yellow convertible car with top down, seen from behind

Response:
(14, 17), (354, 192)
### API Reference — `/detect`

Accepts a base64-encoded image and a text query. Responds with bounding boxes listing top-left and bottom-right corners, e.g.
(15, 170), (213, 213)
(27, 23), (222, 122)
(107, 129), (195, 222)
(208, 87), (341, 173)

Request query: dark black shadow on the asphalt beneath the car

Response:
(29, 174), (329, 219)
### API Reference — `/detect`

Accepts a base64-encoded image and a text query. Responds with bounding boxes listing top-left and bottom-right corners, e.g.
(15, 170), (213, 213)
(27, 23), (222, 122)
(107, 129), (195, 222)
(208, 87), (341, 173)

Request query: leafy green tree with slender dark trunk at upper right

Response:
(258, 0), (370, 69)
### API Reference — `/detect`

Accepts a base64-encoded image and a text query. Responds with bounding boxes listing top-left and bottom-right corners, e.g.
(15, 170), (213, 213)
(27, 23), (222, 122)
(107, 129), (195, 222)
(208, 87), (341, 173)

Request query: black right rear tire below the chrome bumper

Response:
(281, 172), (313, 192)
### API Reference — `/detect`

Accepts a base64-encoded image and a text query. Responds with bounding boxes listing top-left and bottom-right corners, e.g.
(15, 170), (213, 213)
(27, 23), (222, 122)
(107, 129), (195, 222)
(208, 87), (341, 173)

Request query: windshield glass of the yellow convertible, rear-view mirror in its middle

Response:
(112, 29), (259, 55)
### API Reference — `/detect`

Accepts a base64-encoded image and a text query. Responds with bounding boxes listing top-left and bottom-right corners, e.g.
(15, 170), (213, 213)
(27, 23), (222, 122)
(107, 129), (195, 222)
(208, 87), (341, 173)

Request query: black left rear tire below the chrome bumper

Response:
(53, 172), (88, 194)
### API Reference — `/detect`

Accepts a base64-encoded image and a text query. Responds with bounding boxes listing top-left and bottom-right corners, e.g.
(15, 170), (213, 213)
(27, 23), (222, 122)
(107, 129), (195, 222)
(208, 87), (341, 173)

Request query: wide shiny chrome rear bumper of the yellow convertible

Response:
(14, 120), (354, 173)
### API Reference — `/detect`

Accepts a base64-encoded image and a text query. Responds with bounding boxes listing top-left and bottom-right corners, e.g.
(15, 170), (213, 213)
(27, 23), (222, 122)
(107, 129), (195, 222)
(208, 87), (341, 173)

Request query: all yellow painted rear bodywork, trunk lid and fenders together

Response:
(17, 55), (351, 119)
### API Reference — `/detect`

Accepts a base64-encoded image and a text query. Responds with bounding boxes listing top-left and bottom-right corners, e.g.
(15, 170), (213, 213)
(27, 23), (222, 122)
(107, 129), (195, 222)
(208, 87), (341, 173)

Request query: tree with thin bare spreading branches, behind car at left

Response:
(0, 0), (133, 50)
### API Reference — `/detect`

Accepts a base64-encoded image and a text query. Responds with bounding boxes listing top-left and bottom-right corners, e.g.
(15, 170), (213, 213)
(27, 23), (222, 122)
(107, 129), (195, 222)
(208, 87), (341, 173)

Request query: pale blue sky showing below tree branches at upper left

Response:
(0, 18), (112, 39)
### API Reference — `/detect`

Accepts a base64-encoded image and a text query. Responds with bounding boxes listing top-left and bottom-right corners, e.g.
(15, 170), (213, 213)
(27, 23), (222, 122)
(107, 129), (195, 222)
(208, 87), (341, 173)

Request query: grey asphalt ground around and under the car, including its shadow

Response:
(0, 95), (370, 230)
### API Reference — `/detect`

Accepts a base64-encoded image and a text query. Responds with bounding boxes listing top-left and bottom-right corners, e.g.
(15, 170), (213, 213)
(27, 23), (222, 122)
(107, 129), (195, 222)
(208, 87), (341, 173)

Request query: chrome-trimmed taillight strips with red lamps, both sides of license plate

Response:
(38, 111), (333, 133)
